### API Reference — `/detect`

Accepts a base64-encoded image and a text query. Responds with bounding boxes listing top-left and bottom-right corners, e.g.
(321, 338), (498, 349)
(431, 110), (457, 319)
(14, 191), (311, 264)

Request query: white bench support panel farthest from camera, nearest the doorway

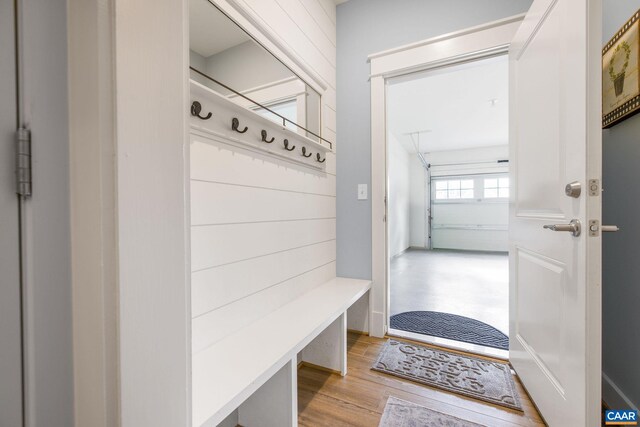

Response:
(302, 312), (347, 376)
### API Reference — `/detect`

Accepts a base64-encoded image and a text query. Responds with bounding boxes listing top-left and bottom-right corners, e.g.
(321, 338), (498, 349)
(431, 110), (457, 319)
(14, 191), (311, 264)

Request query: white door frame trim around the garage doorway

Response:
(369, 14), (524, 337)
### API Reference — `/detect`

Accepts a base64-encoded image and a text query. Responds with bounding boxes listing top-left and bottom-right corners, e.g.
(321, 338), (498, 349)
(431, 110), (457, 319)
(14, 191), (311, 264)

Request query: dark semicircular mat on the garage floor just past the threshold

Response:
(391, 311), (509, 350)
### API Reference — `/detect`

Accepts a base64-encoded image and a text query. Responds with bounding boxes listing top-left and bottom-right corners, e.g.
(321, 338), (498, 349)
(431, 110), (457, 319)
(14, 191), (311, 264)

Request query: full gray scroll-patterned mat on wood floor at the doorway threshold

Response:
(371, 340), (522, 411)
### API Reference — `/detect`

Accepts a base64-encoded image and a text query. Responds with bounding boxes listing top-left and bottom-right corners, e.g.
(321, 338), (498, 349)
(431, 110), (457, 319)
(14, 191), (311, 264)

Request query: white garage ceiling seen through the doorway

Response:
(387, 56), (509, 153)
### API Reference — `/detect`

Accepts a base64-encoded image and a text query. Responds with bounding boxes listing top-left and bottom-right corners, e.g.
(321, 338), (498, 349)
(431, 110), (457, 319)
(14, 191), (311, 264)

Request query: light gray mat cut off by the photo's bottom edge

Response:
(378, 396), (482, 427)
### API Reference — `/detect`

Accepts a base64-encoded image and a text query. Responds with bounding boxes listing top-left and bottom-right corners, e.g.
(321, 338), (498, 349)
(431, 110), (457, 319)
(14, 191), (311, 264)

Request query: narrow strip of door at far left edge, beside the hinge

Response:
(0, 0), (22, 426)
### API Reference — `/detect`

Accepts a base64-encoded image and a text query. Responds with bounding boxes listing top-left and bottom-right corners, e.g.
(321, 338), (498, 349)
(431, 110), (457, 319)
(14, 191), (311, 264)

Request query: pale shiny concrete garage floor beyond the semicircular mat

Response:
(390, 249), (509, 335)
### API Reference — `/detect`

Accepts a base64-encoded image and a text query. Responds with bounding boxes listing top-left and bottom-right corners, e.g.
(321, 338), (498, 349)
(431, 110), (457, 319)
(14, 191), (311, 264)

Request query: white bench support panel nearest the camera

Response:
(238, 359), (298, 427)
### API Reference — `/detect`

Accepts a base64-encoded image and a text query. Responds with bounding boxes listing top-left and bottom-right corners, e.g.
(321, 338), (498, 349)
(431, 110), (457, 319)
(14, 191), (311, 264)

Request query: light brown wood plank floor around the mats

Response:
(298, 333), (544, 427)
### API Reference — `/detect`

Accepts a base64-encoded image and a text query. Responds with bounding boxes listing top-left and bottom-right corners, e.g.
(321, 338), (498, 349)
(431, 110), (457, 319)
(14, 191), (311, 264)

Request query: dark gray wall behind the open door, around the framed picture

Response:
(602, 0), (640, 412)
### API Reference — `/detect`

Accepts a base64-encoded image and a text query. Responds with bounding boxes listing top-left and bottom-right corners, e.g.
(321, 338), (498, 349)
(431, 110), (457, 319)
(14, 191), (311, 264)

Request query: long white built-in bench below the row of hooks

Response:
(192, 278), (371, 427)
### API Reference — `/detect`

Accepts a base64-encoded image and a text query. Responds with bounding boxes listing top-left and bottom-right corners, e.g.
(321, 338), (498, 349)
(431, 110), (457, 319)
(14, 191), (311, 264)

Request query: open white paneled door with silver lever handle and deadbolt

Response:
(509, 0), (601, 427)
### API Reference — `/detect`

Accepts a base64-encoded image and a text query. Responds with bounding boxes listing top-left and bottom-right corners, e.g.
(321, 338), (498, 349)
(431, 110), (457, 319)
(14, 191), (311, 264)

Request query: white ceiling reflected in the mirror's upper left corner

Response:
(189, 0), (251, 58)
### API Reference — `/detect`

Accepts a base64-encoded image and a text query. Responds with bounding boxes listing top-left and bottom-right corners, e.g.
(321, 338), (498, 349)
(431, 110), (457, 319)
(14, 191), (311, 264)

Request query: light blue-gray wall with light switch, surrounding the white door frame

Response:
(337, 0), (531, 279)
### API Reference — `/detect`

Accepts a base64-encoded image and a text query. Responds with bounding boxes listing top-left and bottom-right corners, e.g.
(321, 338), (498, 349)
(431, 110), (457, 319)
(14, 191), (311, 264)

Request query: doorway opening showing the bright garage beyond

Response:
(386, 55), (509, 358)
